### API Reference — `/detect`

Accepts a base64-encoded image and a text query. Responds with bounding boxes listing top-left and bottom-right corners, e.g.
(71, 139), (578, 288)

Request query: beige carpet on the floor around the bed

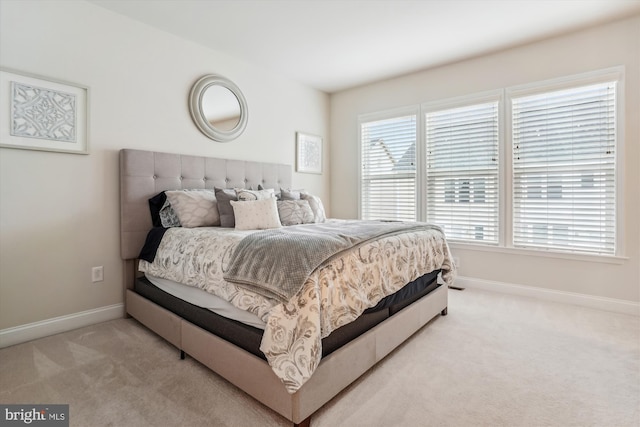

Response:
(0, 289), (640, 427)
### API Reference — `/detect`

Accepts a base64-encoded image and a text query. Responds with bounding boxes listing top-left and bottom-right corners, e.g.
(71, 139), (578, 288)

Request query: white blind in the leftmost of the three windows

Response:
(360, 114), (417, 221)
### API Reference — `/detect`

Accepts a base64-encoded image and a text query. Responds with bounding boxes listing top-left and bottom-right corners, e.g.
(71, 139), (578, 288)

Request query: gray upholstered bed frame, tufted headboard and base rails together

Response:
(120, 149), (447, 427)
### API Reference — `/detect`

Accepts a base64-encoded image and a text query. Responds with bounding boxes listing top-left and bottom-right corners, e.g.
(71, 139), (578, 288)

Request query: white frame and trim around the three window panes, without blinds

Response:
(357, 66), (628, 264)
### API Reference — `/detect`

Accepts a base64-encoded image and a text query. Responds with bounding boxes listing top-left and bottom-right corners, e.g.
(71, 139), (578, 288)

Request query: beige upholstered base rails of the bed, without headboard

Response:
(126, 278), (447, 426)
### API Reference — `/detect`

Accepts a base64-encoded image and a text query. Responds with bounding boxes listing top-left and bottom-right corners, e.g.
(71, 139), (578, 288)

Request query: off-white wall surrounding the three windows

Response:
(331, 15), (640, 309)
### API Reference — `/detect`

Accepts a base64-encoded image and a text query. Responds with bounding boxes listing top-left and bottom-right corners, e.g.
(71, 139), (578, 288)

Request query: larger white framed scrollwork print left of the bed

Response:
(0, 68), (89, 154)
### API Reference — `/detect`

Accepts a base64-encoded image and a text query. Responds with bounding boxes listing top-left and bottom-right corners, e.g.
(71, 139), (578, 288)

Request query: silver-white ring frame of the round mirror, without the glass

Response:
(189, 74), (248, 142)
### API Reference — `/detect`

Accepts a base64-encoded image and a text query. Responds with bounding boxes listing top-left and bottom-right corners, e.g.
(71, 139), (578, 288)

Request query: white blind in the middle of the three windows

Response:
(425, 101), (499, 244)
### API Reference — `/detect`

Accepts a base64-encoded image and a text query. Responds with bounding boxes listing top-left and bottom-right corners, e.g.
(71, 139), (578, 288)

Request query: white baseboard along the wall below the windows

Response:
(454, 276), (640, 316)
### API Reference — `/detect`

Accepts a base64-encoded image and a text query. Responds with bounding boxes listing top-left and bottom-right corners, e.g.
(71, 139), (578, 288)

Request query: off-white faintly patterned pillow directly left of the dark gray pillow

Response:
(165, 190), (220, 228)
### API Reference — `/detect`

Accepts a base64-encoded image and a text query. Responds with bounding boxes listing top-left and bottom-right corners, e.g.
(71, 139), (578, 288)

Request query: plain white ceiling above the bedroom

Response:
(88, 0), (640, 93)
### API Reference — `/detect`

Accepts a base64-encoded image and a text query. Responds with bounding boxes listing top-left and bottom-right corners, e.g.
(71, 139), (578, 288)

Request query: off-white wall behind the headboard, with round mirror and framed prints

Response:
(0, 0), (330, 331)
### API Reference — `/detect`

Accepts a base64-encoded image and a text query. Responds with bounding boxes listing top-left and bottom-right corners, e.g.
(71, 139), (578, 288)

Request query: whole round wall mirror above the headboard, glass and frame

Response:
(189, 74), (247, 142)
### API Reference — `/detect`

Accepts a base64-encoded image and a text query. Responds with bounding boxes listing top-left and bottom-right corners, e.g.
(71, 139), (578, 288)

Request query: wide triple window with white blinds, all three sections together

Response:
(359, 67), (623, 256)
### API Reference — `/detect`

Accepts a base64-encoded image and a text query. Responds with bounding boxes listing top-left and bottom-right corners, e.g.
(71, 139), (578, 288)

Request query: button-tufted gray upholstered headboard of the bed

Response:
(120, 149), (292, 260)
